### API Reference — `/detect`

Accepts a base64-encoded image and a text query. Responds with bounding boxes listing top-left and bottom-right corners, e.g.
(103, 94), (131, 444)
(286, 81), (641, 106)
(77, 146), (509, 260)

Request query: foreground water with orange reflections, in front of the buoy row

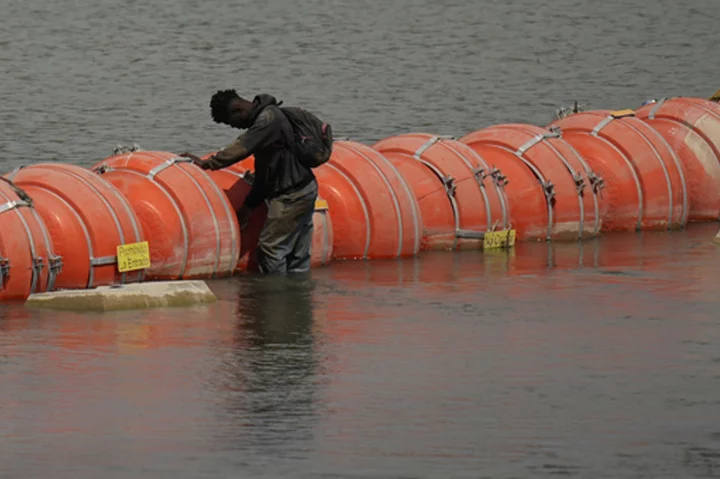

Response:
(0, 225), (720, 478)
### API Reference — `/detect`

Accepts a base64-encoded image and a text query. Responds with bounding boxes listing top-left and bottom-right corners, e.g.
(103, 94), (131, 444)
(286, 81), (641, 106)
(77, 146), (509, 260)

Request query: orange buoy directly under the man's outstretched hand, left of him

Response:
(93, 151), (240, 280)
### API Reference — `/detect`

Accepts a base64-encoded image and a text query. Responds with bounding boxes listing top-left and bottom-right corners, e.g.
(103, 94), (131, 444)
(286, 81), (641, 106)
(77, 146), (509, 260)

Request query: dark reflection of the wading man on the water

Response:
(210, 276), (320, 454)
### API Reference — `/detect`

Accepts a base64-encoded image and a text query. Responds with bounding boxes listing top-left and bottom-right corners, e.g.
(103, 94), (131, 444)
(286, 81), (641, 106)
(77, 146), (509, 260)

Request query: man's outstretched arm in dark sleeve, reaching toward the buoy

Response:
(203, 107), (280, 170)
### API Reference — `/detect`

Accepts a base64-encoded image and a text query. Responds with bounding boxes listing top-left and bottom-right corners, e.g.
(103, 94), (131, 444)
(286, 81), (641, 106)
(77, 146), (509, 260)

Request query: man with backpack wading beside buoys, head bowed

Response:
(181, 90), (332, 274)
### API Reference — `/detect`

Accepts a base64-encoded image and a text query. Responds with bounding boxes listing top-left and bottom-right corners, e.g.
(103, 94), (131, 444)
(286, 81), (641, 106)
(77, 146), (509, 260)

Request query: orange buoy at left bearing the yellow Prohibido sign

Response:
(5, 163), (144, 289)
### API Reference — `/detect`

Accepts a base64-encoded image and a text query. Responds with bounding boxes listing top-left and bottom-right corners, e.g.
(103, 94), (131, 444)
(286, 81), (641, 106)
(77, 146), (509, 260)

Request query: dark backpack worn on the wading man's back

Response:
(280, 107), (333, 168)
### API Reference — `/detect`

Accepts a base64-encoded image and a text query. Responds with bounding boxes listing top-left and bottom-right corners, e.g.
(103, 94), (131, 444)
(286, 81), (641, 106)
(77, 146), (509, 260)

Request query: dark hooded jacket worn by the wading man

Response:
(204, 93), (315, 208)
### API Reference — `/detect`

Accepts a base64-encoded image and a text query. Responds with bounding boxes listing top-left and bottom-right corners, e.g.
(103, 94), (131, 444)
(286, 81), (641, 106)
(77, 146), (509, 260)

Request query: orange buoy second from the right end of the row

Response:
(551, 110), (688, 231)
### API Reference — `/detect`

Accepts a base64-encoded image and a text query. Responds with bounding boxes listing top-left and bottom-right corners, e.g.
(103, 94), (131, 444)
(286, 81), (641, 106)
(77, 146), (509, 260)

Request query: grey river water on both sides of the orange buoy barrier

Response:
(0, 0), (720, 479)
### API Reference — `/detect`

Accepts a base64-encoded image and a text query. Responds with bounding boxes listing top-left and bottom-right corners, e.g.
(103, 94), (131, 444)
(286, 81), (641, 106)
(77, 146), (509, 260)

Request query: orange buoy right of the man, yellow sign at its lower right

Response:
(373, 133), (508, 248)
